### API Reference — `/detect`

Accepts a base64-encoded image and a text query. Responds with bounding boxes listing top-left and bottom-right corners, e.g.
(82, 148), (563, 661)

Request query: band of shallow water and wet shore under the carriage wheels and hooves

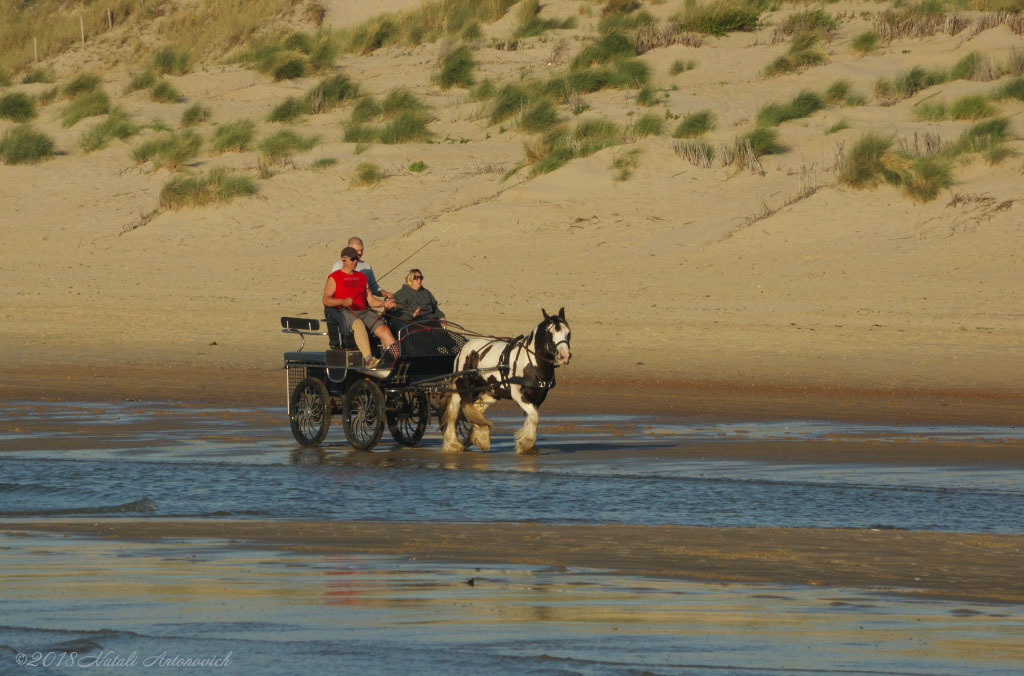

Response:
(0, 403), (1024, 533)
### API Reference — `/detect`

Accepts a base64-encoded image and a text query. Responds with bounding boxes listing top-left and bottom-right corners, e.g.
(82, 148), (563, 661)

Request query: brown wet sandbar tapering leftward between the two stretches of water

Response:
(8, 518), (1024, 603)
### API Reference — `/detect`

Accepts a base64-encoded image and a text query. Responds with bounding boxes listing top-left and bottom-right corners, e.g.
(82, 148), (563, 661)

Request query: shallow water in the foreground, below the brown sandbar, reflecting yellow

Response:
(0, 535), (1024, 676)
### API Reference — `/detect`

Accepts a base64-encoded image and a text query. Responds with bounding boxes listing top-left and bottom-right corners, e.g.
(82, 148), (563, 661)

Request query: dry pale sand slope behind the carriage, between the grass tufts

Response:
(0, 0), (1024, 394)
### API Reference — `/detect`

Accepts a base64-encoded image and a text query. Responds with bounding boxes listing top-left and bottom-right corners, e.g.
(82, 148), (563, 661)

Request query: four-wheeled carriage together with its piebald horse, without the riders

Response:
(281, 309), (571, 453)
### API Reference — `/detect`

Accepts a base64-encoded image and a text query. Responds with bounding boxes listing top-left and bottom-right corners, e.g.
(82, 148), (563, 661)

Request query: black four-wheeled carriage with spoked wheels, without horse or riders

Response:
(281, 316), (470, 451)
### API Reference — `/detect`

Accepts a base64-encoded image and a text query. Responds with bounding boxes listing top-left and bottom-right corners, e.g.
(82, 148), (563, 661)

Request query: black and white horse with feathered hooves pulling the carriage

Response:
(442, 307), (572, 454)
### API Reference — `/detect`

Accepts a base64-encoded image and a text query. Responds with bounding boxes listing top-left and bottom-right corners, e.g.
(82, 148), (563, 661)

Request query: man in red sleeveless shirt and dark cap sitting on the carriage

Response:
(324, 247), (394, 369)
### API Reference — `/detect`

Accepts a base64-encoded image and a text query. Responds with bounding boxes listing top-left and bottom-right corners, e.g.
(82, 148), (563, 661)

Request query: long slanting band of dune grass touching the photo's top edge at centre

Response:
(338, 0), (517, 54)
